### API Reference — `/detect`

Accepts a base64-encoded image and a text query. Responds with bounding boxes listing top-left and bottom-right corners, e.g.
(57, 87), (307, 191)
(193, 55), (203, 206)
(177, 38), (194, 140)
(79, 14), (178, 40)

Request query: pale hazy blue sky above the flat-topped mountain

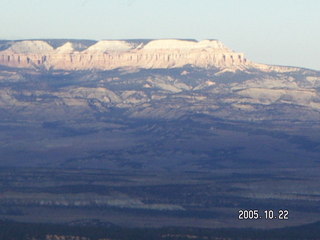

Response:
(0, 0), (320, 70)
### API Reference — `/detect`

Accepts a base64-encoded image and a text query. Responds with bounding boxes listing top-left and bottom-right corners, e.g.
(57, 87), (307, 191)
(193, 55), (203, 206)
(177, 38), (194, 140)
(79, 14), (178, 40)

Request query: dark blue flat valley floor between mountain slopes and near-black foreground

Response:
(0, 168), (320, 229)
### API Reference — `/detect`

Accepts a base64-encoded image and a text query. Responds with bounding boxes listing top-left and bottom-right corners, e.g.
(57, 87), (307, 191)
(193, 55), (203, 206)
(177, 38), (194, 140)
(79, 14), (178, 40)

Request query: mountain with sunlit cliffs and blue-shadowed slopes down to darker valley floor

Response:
(0, 39), (320, 168)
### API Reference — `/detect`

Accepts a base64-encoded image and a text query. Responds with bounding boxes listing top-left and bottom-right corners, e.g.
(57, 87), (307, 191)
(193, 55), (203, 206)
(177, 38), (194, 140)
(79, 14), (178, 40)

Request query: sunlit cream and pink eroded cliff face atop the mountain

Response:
(0, 39), (250, 70)
